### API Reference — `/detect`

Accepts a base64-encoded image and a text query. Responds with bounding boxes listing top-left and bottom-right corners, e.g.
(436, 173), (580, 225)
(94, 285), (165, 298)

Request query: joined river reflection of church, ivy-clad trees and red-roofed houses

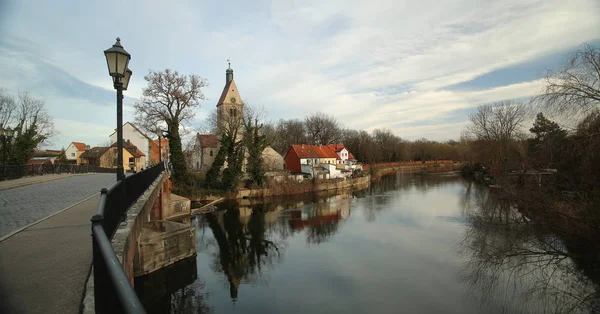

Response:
(204, 194), (353, 300)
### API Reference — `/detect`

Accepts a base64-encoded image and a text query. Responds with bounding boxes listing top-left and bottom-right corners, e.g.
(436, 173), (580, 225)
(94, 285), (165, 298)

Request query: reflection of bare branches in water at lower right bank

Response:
(460, 189), (600, 313)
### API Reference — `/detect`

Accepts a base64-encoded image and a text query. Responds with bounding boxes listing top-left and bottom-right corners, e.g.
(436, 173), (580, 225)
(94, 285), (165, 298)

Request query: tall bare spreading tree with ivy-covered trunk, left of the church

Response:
(134, 69), (208, 180)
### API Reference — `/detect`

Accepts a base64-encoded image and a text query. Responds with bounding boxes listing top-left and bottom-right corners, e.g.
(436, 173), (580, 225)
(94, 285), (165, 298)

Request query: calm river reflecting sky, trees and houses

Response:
(136, 174), (598, 313)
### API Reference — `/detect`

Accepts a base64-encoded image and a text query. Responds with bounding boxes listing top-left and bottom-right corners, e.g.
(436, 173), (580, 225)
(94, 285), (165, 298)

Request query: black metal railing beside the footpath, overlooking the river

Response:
(91, 163), (165, 313)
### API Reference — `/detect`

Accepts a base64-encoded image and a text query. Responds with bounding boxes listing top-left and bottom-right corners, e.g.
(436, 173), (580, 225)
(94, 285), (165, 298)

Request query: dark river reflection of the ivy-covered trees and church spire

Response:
(205, 208), (281, 300)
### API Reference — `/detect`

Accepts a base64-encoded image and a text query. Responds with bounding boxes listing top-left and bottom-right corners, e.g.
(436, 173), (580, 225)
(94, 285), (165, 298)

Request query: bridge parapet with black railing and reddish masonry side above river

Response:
(83, 163), (170, 313)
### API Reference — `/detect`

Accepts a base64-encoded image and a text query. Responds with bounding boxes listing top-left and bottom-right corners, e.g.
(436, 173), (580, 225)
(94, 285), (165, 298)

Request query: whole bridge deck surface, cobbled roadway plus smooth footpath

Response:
(0, 174), (115, 314)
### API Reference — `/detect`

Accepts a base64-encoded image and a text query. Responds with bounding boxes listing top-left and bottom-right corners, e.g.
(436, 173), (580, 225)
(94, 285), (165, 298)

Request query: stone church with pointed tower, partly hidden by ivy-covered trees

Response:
(191, 64), (285, 172)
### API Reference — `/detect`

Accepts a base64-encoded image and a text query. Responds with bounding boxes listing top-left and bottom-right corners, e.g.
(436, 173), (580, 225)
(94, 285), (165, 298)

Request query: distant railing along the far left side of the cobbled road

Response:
(0, 164), (117, 181)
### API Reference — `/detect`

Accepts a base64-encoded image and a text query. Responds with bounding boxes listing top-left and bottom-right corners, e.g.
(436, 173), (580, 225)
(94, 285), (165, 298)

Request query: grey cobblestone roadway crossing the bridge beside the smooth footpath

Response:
(0, 173), (116, 237)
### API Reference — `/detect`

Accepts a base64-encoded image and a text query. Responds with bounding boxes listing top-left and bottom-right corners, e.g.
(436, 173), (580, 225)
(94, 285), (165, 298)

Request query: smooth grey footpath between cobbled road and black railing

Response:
(0, 196), (99, 314)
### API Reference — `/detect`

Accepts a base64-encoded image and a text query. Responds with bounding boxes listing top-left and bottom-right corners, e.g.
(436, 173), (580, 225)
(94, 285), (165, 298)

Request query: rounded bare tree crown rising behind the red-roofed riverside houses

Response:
(304, 112), (342, 145)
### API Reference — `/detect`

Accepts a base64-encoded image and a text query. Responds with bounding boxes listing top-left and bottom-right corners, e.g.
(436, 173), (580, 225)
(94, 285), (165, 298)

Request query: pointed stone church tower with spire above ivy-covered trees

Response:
(217, 63), (244, 129)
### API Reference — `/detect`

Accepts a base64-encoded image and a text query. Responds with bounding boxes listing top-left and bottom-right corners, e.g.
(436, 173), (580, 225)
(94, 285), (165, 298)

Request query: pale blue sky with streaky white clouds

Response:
(0, 0), (600, 148)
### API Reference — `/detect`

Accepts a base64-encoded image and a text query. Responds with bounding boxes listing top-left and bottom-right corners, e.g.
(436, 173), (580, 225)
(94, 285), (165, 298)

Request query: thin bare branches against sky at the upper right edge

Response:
(535, 44), (600, 114)
